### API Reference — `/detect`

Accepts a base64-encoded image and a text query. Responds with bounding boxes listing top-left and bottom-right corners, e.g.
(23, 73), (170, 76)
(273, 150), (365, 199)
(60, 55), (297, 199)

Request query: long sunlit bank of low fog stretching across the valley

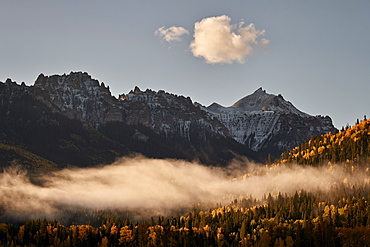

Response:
(0, 157), (369, 223)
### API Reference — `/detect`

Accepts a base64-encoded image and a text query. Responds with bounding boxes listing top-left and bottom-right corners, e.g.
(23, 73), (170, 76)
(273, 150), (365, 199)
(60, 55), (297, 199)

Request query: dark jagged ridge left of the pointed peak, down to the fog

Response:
(0, 72), (261, 167)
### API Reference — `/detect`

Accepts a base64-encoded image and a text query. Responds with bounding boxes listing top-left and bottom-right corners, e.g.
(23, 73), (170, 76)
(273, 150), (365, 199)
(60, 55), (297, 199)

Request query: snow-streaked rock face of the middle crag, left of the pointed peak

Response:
(119, 87), (229, 141)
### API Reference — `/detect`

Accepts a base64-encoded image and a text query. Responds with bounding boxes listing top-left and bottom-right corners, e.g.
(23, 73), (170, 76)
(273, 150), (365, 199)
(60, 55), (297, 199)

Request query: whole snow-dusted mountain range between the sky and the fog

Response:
(0, 72), (336, 170)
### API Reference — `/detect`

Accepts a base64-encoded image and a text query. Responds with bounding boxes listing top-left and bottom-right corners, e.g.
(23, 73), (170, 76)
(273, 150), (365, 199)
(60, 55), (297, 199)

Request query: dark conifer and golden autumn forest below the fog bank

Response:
(0, 178), (370, 247)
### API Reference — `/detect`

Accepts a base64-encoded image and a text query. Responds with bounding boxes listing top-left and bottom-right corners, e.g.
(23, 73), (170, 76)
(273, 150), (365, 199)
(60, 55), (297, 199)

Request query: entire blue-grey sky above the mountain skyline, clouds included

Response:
(0, 0), (370, 128)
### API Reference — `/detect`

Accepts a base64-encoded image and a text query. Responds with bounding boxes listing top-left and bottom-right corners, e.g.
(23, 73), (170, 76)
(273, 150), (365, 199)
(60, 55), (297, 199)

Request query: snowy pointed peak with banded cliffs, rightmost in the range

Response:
(203, 88), (335, 157)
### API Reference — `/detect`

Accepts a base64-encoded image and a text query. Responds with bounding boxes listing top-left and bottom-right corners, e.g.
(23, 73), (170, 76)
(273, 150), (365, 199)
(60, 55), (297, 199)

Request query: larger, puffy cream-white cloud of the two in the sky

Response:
(190, 15), (269, 64)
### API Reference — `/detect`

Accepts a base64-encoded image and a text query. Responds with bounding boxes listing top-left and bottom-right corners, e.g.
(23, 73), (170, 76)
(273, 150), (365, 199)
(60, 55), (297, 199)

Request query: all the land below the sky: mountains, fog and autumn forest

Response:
(0, 72), (370, 246)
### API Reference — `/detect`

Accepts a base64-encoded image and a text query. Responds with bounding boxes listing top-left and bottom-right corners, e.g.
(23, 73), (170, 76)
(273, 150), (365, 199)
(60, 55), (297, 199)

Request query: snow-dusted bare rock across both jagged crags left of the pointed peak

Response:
(34, 72), (228, 141)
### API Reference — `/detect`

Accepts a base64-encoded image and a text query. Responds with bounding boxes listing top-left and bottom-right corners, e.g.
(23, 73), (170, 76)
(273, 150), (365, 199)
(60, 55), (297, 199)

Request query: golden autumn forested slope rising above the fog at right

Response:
(279, 118), (370, 166)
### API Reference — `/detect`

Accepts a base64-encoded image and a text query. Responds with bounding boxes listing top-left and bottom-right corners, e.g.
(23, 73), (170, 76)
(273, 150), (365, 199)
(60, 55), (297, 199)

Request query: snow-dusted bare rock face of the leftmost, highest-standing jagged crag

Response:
(34, 72), (122, 127)
